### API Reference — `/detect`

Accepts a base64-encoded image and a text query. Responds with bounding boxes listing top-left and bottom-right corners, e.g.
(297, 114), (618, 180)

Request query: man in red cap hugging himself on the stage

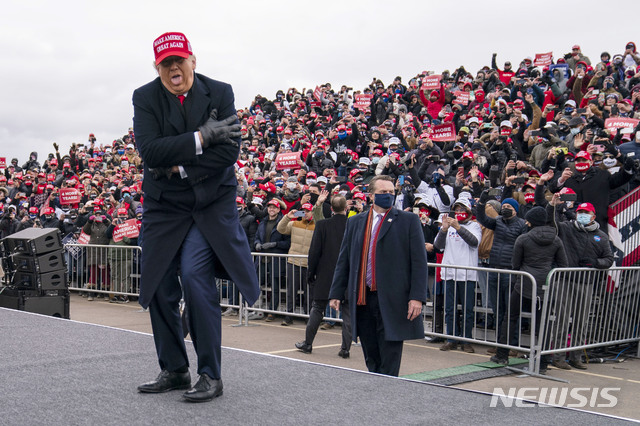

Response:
(133, 33), (260, 402)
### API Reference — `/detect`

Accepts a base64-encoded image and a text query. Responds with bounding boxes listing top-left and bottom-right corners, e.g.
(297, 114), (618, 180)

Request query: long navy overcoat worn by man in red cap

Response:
(133, 74), (260, 307)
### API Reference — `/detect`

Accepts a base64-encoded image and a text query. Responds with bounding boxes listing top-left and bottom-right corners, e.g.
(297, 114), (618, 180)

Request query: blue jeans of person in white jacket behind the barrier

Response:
(444, 280), (476, 342)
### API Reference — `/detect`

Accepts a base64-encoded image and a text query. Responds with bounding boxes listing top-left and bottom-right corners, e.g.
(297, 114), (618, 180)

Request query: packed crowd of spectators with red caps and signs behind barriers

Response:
(0, 42), (640, 368)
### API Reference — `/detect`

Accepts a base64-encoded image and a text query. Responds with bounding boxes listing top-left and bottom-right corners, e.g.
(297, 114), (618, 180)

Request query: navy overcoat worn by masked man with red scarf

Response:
(329, 208), (428, 341)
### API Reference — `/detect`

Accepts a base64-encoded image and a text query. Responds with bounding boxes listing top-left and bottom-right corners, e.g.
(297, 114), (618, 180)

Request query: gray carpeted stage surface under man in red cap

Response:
(0, 308), (622, 426)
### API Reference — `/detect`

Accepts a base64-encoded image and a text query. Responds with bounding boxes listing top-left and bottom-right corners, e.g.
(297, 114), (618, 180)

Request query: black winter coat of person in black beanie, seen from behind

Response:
(512, 226), (569, 299)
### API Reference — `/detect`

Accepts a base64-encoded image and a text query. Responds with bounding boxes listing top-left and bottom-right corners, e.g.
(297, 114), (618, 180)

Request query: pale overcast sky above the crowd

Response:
(0, 0), (640, 163)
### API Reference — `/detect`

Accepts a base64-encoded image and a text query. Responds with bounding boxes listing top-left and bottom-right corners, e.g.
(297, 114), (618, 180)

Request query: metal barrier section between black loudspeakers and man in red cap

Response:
(64, 244), (142, 301)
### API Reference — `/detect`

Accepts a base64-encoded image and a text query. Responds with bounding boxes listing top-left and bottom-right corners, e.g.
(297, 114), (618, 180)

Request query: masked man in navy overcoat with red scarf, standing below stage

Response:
(329, 175), (428, 376)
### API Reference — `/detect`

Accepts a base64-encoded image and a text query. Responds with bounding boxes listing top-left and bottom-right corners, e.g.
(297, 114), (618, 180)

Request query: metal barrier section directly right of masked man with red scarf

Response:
(423, 263), (541, 371)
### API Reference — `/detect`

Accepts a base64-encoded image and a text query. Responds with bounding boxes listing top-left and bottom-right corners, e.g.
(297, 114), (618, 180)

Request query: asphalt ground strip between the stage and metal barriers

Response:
(70, 293), (640, 420)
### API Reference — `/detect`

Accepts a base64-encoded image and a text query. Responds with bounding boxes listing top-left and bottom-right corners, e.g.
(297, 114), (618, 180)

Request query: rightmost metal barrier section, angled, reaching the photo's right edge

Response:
(536, 267), (640, 365)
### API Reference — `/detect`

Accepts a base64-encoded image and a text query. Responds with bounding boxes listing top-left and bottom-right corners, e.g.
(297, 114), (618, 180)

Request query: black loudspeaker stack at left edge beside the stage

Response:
(0, 228), (69, 319)
